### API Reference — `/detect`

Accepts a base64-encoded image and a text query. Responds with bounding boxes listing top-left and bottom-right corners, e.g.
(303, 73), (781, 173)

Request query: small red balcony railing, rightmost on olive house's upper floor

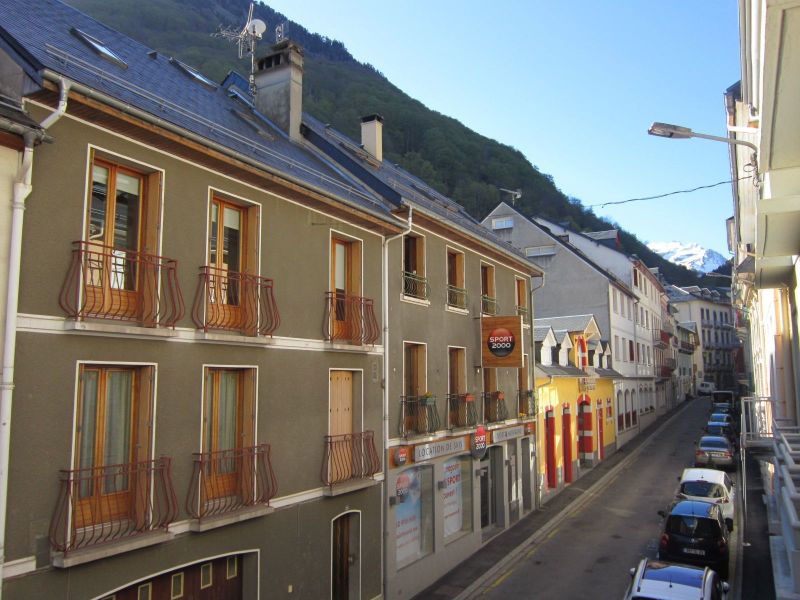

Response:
(322, 292), (381, 345)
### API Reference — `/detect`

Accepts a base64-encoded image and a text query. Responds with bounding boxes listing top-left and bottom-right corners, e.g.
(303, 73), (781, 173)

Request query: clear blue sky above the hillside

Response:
(265, 0), (741, 257)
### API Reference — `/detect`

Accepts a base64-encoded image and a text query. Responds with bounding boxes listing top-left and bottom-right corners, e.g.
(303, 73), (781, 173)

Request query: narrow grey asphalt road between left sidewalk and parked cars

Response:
(472, 398), (738, 600)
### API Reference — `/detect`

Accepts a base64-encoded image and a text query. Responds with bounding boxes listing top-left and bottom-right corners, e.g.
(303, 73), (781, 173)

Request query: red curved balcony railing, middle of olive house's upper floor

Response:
(192, 266), (281, 336)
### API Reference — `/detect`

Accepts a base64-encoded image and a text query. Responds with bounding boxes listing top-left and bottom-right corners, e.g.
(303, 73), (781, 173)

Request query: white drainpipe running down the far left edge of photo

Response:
(0, 82), (69, 597)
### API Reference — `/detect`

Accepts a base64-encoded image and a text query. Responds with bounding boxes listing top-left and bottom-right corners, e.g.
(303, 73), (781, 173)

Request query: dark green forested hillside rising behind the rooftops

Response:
(67, 0), (718, 285)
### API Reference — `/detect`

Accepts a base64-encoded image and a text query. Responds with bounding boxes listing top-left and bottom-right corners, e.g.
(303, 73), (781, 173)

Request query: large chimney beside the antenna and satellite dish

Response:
(255, 40), (303, 141)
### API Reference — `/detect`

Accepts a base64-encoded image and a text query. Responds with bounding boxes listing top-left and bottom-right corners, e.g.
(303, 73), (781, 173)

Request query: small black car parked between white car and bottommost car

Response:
(658, 500), (730, 579)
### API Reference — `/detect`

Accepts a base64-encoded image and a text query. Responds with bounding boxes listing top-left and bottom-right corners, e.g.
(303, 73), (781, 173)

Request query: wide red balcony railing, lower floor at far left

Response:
(50, 456), (178, 554)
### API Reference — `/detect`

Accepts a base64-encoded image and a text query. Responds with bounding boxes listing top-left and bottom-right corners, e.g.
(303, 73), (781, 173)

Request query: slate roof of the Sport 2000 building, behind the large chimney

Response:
(303, 113), (538, 270)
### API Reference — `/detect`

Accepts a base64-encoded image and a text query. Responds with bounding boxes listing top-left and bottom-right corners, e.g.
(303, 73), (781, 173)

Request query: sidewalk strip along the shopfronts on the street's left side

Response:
(414, 399), (698, 600)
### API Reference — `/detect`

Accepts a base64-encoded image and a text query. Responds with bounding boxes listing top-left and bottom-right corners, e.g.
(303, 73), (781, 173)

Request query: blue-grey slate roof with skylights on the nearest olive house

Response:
(0, 0), (390, 219)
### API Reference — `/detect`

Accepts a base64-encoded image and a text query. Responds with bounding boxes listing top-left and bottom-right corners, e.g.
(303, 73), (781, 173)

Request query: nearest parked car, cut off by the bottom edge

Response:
(624, 558), (729, 600)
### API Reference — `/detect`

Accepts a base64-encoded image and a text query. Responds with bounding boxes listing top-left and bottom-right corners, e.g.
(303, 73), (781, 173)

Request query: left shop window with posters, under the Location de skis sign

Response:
(394, 467), (433, 568)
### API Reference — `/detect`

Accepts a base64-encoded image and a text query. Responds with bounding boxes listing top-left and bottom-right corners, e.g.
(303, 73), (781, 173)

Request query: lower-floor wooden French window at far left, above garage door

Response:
(74, 365), (153, 527)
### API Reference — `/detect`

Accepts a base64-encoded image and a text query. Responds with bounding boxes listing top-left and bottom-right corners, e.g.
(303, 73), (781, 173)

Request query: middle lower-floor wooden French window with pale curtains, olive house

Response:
(203, 367), (255, 499)
